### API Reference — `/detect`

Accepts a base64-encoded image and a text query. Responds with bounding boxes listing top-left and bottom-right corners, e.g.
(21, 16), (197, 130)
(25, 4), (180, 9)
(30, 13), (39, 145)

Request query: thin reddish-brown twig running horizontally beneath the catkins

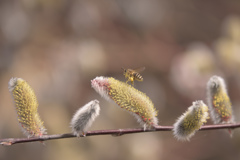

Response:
(0, 123), (240, 146)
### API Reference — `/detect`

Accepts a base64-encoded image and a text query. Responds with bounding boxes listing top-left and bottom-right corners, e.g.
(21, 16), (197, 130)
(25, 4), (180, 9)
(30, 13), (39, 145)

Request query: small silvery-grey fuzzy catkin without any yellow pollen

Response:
(70, 100), (100, 137)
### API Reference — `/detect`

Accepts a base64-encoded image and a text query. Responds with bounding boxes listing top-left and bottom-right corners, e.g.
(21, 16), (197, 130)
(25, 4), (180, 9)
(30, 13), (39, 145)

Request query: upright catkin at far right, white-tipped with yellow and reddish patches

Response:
(207, 76), (234, 134)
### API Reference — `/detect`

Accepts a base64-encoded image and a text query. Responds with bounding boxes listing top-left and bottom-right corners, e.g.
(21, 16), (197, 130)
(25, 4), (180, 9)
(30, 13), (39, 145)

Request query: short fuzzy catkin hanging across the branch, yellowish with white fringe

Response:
(173, 101), (209, 141)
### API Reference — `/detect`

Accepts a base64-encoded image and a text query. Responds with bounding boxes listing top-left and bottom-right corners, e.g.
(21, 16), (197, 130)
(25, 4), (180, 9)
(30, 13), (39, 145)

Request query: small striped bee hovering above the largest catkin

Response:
(122, 67), (145, 85)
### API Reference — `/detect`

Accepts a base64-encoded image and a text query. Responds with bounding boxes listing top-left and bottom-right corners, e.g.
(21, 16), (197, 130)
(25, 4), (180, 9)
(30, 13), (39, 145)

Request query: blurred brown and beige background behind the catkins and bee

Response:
(0, 0), (240, 160)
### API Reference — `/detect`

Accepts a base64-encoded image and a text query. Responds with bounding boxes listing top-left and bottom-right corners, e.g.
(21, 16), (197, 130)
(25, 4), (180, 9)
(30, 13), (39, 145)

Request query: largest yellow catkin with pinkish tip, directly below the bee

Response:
(91, 77), (158, 130)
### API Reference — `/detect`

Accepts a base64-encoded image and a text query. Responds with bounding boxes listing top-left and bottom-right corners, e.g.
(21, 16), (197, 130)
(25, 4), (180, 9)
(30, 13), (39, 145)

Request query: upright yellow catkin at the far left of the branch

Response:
(8, 78), (46, 137)
